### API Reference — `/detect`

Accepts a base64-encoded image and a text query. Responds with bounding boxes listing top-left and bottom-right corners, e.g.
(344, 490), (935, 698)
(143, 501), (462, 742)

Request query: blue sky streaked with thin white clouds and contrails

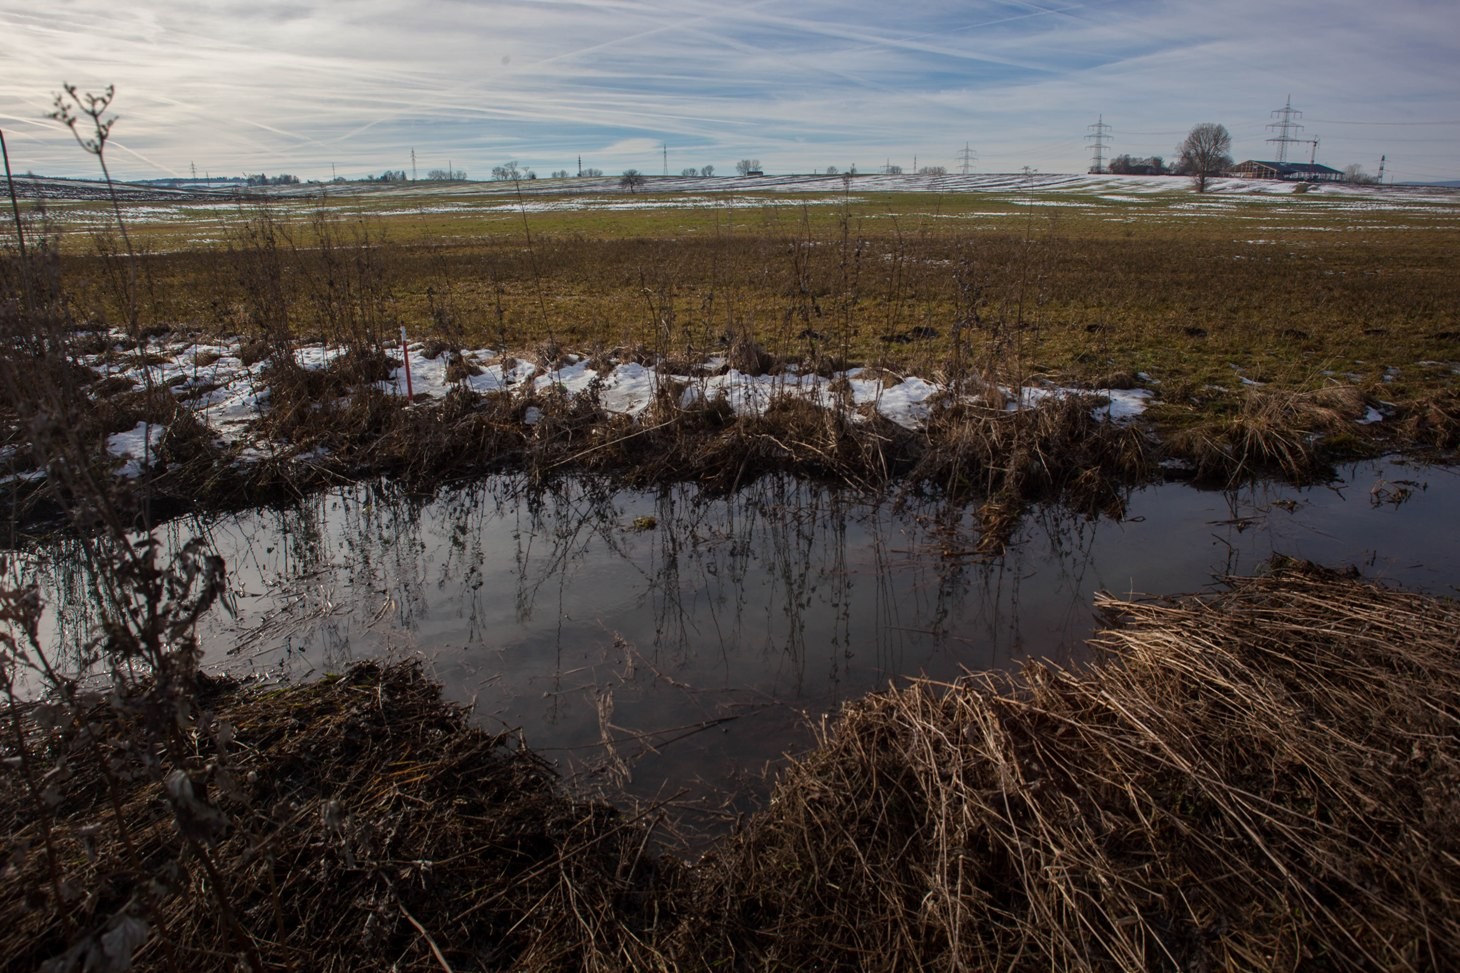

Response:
(0, 0), (1460, 181)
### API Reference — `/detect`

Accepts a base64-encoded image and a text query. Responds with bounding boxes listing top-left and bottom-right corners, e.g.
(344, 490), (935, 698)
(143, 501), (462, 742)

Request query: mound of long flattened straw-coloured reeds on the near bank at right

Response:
(685, 558), (1460, 970)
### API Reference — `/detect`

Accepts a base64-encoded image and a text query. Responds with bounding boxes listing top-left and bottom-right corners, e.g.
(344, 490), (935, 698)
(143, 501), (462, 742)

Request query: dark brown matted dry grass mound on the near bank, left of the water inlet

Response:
(0, 665), (683, 972)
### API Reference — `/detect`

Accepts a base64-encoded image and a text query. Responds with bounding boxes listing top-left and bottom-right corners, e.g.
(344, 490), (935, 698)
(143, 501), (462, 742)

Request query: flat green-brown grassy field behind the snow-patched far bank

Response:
(34, 180), (1460, 400)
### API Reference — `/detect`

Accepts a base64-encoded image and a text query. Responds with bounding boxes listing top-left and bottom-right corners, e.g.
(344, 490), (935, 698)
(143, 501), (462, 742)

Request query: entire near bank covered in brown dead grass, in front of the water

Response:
(0, 564), (1460, 970)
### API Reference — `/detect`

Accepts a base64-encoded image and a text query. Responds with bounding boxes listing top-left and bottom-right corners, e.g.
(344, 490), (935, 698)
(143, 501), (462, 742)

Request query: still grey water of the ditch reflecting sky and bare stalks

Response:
(12, 466), (1460, 829)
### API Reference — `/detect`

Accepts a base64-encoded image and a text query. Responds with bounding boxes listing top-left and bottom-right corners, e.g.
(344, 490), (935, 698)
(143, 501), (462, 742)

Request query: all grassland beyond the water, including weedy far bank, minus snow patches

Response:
(0, 178), (1460, 536)
